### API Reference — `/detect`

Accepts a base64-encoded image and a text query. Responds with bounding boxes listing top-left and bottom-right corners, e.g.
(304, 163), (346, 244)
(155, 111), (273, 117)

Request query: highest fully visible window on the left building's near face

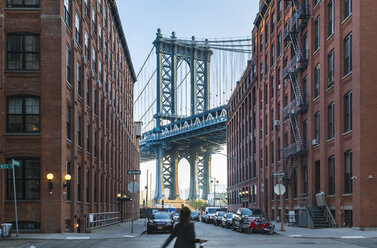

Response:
(7, 34), (40, 70)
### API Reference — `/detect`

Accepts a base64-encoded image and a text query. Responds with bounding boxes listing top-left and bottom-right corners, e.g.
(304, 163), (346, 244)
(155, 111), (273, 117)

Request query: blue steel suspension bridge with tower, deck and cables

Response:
(134, 29), (251, 202)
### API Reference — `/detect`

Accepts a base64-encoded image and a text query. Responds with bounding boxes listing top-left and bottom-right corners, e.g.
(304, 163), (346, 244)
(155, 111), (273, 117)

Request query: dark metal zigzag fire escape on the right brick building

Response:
(282, 0), (309, 184)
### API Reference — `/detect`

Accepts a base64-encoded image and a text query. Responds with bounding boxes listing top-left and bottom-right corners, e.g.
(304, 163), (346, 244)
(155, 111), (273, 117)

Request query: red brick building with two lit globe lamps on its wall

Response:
(0, 0), (139, 232)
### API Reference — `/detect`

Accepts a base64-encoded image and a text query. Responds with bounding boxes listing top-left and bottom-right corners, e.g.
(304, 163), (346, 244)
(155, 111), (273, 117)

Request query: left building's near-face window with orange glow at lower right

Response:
(7, 96), (40, 133)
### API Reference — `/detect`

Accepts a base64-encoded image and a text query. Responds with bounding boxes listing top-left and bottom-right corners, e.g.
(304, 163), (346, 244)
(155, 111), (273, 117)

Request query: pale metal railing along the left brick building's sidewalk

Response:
(85, 212), (120, 231)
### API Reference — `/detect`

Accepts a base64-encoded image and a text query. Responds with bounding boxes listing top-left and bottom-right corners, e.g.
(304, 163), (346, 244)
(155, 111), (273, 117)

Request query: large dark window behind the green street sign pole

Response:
(6, 158), (40, 200)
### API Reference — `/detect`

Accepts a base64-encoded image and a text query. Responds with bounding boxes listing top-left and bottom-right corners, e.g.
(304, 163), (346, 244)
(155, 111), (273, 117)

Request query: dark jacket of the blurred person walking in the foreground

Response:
(162, 222), (199, 248)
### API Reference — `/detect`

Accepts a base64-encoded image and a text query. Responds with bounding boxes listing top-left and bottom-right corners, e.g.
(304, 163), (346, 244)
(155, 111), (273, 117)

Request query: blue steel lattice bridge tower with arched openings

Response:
(153, 29), (213, 201)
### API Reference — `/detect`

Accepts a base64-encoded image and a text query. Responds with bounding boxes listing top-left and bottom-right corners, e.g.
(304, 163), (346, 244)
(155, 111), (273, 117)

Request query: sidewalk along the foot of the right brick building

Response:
(272, 222), (377, 239)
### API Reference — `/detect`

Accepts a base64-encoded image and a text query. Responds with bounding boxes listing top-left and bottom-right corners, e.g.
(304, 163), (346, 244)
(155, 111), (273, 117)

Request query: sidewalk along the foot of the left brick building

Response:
(8, 219), (147, 240)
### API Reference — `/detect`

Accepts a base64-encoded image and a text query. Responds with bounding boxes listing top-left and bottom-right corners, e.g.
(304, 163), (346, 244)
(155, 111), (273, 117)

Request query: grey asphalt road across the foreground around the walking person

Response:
(0, 222), (377, 248)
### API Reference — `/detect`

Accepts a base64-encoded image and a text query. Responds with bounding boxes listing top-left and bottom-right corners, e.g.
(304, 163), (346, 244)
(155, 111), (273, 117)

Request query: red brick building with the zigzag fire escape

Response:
(227, 0), (377, 227)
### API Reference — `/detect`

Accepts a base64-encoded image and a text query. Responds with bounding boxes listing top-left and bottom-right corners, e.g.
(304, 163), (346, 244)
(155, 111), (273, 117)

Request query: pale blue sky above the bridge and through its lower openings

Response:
(116, 0), (259, 200)
